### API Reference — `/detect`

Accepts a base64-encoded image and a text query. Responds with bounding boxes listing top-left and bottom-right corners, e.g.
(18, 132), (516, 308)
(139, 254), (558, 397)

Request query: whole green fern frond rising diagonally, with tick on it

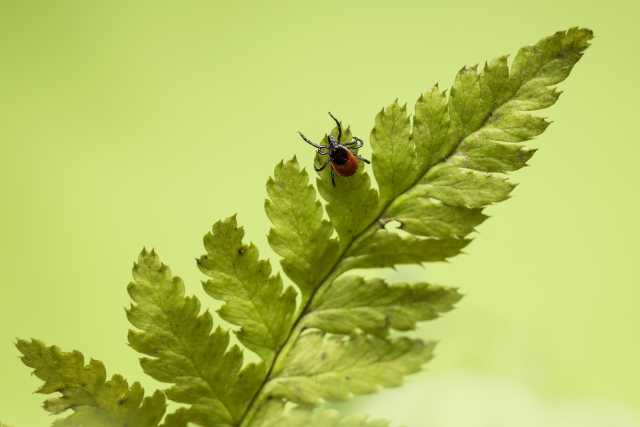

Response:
(17, 28), (592, 427)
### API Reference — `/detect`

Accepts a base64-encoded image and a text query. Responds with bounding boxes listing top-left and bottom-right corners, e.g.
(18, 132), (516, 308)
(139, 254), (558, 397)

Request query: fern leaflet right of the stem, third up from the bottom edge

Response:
(304, 276), (462, 335)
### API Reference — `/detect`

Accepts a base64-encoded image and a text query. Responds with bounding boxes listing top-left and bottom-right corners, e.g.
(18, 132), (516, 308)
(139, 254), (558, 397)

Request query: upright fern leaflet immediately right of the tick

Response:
(371, 101), (416, 204)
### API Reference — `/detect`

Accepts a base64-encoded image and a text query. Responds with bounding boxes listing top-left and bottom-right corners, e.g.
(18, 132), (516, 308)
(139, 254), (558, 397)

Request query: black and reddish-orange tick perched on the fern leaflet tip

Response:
(298, 113), (370, 187)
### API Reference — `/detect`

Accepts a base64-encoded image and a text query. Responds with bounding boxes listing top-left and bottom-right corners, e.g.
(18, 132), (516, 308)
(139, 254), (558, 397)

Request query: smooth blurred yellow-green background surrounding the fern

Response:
(0, 0), (640, 427)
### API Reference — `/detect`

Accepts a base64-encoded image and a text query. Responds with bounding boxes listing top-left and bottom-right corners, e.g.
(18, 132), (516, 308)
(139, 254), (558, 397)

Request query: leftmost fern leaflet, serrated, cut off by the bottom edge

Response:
(16, 340), (166, 427)
